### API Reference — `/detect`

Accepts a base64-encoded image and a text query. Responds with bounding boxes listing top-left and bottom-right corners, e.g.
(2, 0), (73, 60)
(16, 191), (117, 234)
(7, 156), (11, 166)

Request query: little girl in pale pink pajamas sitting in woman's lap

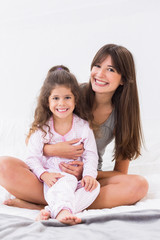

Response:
(26, 66), (100, 225)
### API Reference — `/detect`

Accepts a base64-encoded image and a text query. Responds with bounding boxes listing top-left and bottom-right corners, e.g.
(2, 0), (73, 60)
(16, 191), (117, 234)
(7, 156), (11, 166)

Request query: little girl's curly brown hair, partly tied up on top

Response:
(27, 65), (88, 139)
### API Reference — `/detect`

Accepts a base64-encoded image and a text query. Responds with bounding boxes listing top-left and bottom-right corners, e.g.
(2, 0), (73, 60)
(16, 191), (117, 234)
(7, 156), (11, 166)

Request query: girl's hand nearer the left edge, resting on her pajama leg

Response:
(41, 172), (64, 187)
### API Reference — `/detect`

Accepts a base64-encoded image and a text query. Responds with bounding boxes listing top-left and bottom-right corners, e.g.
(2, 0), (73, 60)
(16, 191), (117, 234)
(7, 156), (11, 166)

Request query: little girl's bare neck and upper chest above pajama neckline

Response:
(53, 114), (73, 135)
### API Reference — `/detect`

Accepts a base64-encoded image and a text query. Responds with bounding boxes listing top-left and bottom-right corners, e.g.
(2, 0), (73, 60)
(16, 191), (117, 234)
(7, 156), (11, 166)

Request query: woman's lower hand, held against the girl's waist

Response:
(59, 161), (83, 180)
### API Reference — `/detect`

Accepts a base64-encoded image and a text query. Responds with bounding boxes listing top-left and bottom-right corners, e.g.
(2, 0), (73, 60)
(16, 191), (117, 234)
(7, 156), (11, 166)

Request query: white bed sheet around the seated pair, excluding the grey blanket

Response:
(0, 119), (160, 219)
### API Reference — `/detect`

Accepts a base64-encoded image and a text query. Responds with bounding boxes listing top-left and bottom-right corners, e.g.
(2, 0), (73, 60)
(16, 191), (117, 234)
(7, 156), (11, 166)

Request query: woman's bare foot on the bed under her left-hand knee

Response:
(3, 198), (44, 210)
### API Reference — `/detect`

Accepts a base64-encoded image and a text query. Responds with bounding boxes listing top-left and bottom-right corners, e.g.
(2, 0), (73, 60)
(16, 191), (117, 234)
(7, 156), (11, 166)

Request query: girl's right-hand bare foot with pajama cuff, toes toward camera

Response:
(56, 210), (82, 225)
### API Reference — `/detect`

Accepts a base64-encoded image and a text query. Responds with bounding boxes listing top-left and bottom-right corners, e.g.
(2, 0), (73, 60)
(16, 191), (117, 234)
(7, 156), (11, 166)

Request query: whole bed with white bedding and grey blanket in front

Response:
(0, 118), (160, 240)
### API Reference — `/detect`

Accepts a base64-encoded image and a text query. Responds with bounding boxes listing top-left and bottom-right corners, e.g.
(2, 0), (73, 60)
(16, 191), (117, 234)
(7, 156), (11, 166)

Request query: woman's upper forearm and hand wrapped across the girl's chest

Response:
(43, 138), (84, 160)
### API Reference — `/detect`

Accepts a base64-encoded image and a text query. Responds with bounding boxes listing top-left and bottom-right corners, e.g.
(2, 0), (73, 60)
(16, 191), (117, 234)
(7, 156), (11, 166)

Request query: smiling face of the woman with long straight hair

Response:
(91, 56), (123, 94)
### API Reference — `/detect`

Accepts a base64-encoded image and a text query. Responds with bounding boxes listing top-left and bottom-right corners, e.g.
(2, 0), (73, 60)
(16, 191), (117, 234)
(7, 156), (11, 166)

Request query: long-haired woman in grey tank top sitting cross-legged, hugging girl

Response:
(0, 44), (148, 209)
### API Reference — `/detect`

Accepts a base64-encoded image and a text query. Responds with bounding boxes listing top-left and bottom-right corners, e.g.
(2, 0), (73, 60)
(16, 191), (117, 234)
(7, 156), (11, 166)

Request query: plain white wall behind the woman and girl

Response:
(0, 0), (160, 124)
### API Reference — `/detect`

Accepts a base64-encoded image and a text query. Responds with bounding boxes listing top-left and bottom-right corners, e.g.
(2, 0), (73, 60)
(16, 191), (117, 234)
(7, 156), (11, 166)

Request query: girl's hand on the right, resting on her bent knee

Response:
(81, 176), (98, 192)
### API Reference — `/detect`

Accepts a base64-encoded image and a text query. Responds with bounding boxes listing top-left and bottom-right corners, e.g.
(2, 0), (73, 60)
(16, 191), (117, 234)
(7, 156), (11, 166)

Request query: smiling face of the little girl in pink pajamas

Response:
(48, 86), (75, 118)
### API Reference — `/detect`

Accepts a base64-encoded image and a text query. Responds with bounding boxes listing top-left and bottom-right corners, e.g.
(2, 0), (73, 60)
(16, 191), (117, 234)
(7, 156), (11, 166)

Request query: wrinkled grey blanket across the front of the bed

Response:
(0, 210), (160, 240)
